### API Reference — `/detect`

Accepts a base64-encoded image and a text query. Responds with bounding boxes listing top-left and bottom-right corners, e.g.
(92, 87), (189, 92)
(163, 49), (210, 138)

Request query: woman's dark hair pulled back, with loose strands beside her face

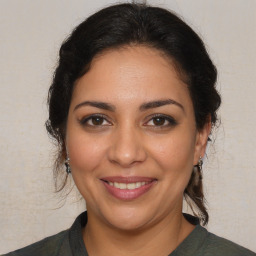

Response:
(46, 4), (221, 224)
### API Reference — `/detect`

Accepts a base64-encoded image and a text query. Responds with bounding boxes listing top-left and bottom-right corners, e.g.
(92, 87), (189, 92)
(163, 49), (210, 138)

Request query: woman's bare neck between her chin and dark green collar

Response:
(83, 208), (194, 256)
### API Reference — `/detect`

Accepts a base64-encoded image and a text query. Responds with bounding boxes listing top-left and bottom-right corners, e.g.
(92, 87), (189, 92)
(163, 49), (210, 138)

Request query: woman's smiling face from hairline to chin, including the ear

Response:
(66, 46), (209, 230)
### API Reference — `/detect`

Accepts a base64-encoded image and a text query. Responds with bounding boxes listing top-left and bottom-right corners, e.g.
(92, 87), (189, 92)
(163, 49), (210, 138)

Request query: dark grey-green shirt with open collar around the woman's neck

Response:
(2, 212), (256, 256)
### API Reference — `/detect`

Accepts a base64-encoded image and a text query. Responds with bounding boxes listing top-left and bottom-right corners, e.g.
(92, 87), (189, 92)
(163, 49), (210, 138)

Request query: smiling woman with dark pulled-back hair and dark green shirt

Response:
(2, 4), (255, 256)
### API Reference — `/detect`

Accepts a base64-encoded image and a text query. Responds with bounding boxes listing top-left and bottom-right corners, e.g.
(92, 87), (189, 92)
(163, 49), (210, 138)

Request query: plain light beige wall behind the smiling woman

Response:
(0, 0), (256, 253)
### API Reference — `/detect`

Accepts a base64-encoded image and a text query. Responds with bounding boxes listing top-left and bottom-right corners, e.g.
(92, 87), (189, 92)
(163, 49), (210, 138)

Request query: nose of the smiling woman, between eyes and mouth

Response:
(108, 124), (147, 168)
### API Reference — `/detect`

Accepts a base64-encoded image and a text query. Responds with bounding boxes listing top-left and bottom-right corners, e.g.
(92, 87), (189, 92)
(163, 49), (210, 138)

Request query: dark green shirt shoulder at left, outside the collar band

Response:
(2, 230), (68, 256)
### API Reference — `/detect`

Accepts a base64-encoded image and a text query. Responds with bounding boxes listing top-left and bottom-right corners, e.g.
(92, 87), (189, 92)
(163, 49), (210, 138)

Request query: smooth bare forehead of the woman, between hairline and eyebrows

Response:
(72, 46), (190, 109)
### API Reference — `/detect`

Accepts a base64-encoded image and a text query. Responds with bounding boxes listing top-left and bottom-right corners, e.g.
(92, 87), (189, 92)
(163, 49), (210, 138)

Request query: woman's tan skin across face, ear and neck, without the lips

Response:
(66, 46), (210, 256)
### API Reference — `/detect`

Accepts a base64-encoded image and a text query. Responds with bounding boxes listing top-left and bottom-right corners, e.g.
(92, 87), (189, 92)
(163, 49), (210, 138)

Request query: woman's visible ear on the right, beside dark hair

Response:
(194, 117), (212, 165)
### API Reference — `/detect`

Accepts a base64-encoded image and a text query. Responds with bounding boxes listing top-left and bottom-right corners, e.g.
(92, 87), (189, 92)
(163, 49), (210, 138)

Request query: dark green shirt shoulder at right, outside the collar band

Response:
(202, 232), (256, 256)
